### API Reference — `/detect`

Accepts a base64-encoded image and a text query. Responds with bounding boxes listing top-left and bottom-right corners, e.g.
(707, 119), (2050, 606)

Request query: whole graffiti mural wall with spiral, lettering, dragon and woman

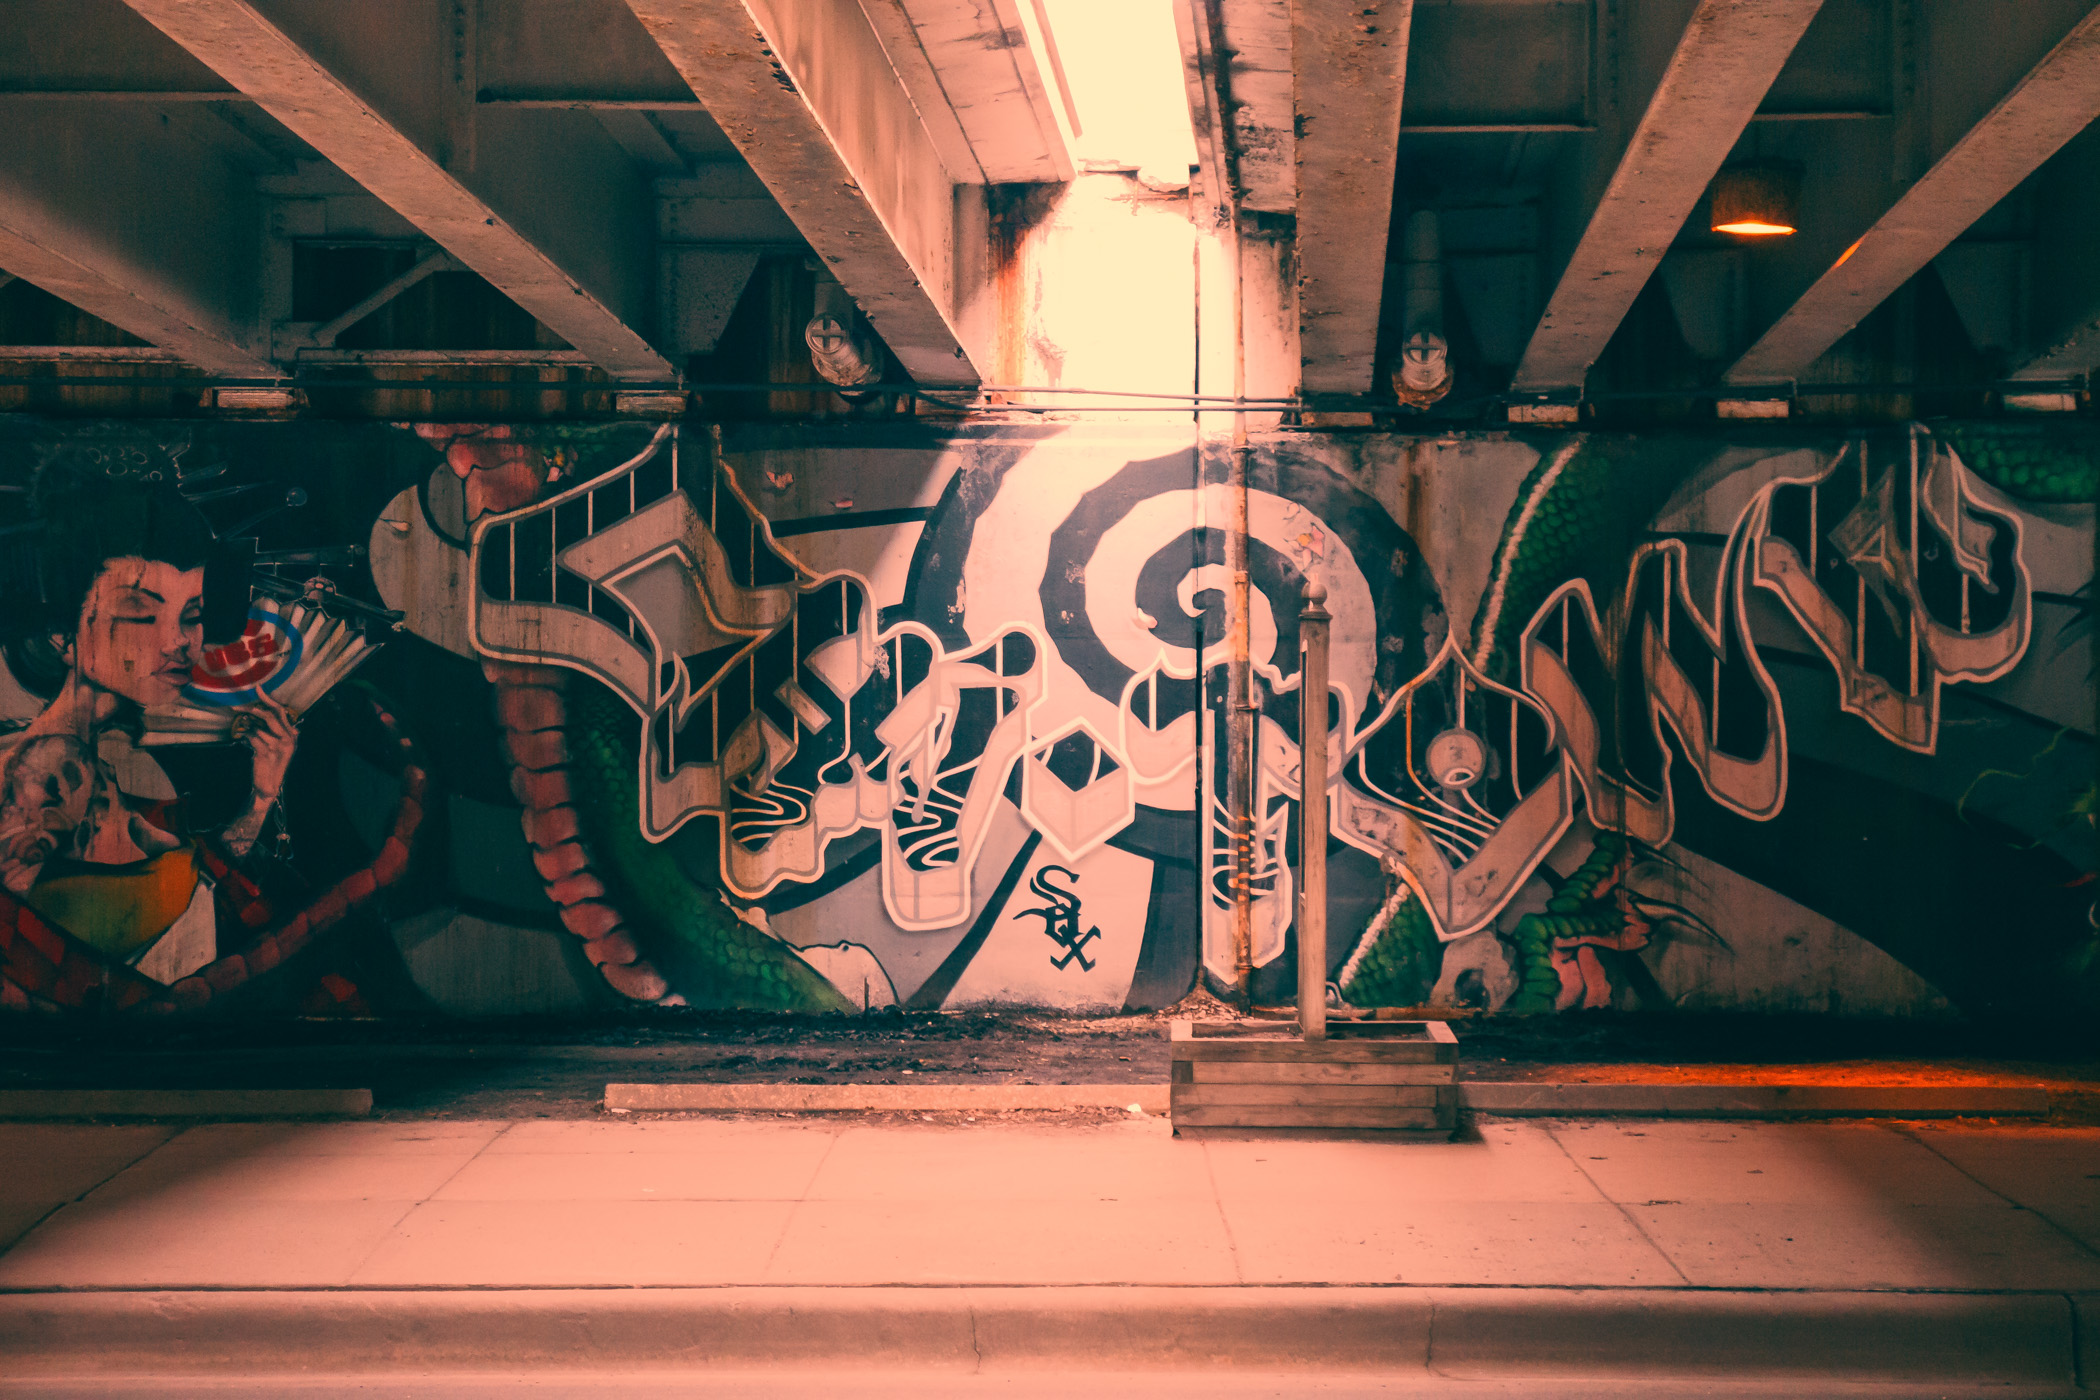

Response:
(0, 413), (2100, 1016)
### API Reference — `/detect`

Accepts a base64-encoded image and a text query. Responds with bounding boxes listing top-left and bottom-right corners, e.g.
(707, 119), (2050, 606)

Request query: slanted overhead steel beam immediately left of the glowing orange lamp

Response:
(1510, 0), (1823, 393)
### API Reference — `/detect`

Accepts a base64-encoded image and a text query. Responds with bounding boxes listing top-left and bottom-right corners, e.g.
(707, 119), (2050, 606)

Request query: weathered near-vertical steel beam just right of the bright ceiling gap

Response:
(1292, 0), (1413, 395)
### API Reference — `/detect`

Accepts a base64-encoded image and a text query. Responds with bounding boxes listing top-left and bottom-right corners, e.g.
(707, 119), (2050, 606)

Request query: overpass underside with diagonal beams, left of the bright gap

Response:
(0, 0), (1073, 384)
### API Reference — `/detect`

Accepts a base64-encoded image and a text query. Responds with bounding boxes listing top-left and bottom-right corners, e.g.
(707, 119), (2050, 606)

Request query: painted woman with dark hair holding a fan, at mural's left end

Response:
(0, 442), (422, 1012)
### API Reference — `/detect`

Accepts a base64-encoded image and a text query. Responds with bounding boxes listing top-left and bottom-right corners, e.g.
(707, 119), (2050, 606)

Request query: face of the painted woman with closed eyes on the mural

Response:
(74, 558), (204, 707)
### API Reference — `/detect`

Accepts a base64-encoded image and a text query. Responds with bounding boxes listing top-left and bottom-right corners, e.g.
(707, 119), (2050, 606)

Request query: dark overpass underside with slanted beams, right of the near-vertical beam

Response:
(1397, 0), (2100, 411)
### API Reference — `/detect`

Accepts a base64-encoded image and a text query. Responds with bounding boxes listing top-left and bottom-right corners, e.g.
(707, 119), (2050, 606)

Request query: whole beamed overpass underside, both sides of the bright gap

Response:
(0, 0), (2100, 411)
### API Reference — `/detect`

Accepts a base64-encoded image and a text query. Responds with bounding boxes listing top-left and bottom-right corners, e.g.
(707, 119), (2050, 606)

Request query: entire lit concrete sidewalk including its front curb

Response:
(0, 1115), (2100, 1394)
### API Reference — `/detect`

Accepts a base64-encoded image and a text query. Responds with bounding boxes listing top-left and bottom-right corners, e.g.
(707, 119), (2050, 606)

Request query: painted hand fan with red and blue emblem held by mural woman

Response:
(145, 590), (393, 747)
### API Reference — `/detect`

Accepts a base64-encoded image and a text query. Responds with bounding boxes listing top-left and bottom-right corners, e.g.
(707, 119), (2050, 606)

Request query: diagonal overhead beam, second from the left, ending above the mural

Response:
(126, 0), (674, 380)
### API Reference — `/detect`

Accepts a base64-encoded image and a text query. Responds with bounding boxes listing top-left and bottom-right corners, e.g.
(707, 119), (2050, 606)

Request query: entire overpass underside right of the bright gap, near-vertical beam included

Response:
(1176, 0), (2100, 403)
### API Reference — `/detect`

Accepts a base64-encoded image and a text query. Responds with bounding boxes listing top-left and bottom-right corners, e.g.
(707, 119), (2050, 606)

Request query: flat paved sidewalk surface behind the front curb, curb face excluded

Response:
(0, 1117), (2100, 1291)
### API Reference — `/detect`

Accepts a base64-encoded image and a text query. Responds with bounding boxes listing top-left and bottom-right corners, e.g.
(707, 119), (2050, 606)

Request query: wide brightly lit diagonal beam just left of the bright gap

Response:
(628, 0), (983, 384)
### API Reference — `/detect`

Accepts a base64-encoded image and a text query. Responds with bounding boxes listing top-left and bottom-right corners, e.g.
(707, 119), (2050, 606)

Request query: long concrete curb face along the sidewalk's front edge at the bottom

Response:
(0, 1287), (2096, 1392)
